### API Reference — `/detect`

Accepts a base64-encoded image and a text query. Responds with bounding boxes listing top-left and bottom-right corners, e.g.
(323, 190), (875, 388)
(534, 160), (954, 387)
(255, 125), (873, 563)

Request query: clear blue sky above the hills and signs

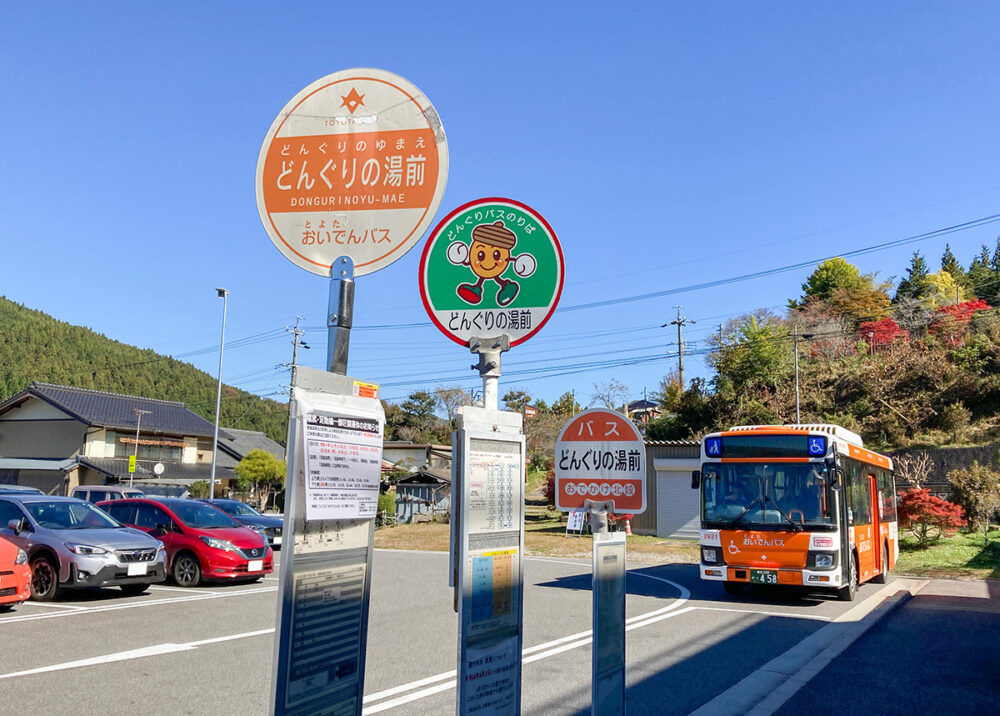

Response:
(0, 2), (1000, 404)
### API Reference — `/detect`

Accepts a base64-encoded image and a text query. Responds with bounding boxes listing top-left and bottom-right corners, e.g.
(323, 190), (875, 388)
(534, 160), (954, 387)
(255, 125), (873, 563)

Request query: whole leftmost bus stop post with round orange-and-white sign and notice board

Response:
(256, 69), (448, 716)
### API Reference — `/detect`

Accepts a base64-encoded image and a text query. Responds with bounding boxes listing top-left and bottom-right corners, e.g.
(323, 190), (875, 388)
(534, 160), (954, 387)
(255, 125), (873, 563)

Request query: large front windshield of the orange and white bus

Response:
(701, 462), (836, 530)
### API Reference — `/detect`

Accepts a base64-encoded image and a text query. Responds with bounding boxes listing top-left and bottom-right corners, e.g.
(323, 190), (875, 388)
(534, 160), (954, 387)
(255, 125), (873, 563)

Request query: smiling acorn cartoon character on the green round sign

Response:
(448, 221), (537, 306)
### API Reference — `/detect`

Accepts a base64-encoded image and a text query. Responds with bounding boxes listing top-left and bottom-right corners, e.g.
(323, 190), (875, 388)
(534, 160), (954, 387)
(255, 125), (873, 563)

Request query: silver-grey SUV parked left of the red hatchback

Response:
(0, 493), (167, 602)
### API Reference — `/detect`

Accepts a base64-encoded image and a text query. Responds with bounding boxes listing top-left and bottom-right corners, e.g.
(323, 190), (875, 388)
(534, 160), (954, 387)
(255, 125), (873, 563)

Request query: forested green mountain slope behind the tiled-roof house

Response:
(0, 296), (287, 443)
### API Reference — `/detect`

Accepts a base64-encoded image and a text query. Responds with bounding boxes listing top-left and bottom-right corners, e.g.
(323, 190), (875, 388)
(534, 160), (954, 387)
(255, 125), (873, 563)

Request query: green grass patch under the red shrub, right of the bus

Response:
(896, 530), (1000, 579)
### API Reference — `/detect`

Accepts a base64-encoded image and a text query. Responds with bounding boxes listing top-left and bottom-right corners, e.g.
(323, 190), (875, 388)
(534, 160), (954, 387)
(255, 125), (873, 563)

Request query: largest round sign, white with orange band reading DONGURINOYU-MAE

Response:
(256, 69), (448, 276)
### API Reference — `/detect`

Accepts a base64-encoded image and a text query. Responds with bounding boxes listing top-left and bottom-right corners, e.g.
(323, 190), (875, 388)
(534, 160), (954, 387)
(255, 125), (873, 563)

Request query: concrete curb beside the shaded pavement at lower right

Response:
(692, 578), (928, 716)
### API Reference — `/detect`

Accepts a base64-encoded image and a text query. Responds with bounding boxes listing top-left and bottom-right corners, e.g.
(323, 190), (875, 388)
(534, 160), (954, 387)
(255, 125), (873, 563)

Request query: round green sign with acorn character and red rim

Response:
(420, 198), (564, 346)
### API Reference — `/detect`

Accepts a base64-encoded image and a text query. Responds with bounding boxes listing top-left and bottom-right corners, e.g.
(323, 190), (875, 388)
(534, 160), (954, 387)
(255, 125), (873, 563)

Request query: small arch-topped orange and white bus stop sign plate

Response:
(555, 408), (646, 514)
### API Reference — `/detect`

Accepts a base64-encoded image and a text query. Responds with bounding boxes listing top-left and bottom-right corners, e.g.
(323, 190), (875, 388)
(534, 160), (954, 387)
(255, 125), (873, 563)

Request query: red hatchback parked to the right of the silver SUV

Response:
(97, 498), (274, 587)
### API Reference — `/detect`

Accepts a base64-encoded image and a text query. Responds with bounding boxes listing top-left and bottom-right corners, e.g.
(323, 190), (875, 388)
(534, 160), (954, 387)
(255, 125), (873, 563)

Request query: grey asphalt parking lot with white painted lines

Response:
(0, 550), (984, 715)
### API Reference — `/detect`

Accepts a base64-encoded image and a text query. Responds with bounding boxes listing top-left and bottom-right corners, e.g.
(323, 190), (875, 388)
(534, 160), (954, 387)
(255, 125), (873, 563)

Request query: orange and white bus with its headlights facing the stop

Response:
(691, 424), (899, 601)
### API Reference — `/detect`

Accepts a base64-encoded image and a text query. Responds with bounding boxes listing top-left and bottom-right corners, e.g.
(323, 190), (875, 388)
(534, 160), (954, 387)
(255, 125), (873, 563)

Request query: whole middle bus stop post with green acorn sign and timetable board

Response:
(420, 198), (564, 716)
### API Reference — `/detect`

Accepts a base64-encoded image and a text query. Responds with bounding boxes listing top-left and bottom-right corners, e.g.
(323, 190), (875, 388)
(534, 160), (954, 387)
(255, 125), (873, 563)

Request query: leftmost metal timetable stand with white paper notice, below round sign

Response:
(271, 366), (385, 716)
